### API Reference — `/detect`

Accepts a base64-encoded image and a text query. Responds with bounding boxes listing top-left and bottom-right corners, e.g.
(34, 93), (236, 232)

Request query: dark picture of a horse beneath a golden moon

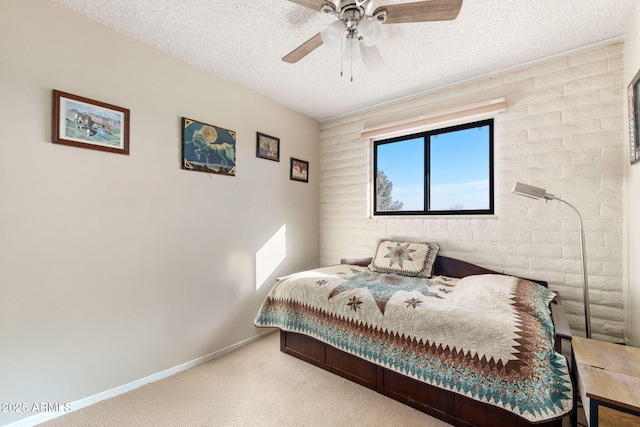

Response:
(182, 117), (236, 176)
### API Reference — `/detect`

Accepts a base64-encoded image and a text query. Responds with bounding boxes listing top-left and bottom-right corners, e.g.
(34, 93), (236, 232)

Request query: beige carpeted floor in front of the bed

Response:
(40, 333), (580, 427)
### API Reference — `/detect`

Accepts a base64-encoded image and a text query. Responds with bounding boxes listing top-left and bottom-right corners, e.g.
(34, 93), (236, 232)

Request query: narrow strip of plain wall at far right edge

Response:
(622, 6), (640, 347)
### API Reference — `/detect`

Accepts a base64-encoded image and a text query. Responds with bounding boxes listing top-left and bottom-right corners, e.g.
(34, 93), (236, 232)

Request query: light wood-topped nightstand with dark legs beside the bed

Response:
(572, 337), (640, 427)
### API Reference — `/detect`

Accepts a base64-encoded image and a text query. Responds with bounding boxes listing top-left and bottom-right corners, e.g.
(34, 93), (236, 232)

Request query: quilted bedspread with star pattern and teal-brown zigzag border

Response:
(255, 265), (573, 422)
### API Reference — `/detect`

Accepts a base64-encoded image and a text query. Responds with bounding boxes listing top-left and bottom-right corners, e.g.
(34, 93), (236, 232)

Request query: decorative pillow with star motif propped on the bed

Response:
(369, 239), (440, 277)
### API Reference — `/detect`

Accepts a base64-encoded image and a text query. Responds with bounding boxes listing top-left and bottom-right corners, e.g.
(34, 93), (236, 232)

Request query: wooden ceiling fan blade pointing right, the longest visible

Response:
(373, 0), (462, 24)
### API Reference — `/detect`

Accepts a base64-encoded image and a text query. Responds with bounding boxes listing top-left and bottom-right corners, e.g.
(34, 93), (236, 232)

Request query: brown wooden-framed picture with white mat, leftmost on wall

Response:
(52, 89), (130, 155)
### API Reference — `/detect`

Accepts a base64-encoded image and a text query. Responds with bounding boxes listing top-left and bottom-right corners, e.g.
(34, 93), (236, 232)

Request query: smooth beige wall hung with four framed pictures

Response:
(0, 0), (318, 425)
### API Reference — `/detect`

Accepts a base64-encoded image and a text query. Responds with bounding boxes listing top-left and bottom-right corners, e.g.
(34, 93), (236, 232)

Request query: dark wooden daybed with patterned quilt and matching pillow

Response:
(255, 239), (575, 427)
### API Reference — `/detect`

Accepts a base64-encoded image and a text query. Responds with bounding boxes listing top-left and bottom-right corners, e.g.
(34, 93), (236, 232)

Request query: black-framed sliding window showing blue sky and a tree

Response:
(373, 119), (493, 215)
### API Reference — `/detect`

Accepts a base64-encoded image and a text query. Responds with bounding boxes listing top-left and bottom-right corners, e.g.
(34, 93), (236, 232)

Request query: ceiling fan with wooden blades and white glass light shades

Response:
(282, 0), (462, 71)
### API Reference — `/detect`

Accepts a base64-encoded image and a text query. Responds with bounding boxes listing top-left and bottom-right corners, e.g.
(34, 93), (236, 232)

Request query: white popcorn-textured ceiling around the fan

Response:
(54, 0), (640, 120)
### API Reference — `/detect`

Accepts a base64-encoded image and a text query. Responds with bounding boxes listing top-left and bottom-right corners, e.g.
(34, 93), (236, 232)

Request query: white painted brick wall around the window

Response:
(320, 43), (626, 341)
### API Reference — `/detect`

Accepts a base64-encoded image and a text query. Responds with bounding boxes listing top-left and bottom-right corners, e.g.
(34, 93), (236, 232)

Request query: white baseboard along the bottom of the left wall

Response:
(5, 330), (275, 427)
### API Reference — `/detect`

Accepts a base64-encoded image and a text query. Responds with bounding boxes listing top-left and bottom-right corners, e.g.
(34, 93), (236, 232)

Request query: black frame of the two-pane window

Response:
(372, 118), (495, 217)
